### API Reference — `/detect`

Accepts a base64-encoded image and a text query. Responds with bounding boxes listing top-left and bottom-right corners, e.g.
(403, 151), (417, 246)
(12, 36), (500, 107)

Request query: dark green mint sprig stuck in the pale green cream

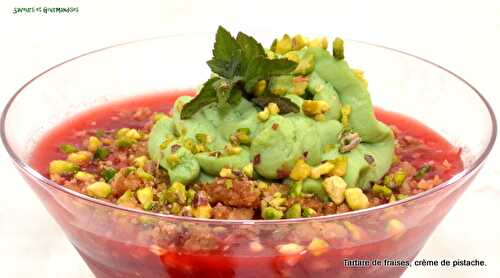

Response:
(181, 26), (300, 119)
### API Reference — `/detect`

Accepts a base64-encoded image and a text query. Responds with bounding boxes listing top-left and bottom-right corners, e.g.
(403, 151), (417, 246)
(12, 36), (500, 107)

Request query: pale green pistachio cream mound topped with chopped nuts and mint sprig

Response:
(148, 27), (395, 194)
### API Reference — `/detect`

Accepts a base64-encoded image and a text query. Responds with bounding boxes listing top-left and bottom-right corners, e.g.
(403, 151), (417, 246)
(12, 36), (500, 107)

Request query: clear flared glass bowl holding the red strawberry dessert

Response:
(1, 35), (496, 278)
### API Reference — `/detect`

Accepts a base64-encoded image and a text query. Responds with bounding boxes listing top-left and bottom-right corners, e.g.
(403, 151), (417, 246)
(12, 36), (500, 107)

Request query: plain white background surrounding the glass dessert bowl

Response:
(0, 0), (500, 278)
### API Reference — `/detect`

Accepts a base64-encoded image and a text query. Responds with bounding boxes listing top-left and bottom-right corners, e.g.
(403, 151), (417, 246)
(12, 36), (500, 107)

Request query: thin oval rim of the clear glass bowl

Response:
(0, 33), (497, 225)
